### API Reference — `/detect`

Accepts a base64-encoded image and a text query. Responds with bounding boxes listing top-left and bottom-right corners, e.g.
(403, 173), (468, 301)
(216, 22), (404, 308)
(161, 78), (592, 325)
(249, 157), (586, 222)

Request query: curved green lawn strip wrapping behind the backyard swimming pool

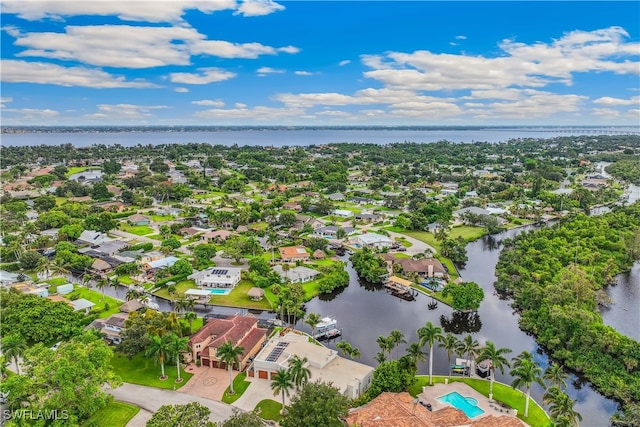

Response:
(408, 375), (550, 427)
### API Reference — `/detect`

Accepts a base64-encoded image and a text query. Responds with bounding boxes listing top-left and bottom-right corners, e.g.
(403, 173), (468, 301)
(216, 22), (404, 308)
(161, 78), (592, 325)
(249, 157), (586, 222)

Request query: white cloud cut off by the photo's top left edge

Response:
(2, 0), (237, 22)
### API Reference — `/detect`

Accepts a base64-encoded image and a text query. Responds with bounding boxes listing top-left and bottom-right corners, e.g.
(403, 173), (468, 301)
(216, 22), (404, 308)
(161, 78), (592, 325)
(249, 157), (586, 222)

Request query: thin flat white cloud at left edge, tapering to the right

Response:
(1, 59), (158, 89)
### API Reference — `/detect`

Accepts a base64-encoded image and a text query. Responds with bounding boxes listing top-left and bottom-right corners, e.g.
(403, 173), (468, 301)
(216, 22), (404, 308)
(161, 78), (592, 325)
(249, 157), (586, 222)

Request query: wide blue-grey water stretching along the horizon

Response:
(0, 127), (640, 147)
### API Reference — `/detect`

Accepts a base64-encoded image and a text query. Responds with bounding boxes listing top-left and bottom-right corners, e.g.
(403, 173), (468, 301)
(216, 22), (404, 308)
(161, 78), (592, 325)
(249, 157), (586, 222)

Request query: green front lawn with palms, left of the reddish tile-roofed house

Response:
(111, 353), (193, 390)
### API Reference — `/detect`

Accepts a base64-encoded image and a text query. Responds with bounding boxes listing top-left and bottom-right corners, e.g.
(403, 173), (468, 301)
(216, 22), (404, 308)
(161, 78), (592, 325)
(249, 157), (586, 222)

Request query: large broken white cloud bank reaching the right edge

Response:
(362, 27), (640, 91)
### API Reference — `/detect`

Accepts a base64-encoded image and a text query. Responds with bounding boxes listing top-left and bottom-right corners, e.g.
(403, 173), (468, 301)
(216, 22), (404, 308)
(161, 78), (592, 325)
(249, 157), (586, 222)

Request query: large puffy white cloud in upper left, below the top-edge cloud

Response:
(3, 25), (299, 68)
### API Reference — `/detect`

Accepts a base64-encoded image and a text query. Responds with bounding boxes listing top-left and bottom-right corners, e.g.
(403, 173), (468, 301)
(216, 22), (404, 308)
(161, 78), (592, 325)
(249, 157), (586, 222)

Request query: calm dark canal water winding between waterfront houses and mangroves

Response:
(297, 227), (640, 427)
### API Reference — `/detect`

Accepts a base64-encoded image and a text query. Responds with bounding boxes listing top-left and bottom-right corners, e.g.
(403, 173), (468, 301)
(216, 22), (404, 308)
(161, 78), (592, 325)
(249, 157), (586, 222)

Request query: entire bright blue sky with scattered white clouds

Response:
(0, 0), (640, 126)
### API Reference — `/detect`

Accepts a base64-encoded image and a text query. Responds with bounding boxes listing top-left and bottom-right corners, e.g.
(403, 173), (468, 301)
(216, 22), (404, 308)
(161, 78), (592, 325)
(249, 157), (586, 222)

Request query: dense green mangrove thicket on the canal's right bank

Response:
(495, 203), (640, 422)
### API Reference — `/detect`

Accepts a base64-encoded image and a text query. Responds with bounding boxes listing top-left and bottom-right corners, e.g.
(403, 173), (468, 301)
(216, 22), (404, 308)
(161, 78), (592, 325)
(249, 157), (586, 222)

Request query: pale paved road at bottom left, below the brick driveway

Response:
(107, 383), (238, 422)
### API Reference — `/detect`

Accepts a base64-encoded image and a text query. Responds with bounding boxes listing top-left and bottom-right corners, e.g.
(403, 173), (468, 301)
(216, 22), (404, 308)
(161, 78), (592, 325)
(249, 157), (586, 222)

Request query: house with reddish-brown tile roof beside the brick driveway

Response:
(188, 316), (267, 371)
